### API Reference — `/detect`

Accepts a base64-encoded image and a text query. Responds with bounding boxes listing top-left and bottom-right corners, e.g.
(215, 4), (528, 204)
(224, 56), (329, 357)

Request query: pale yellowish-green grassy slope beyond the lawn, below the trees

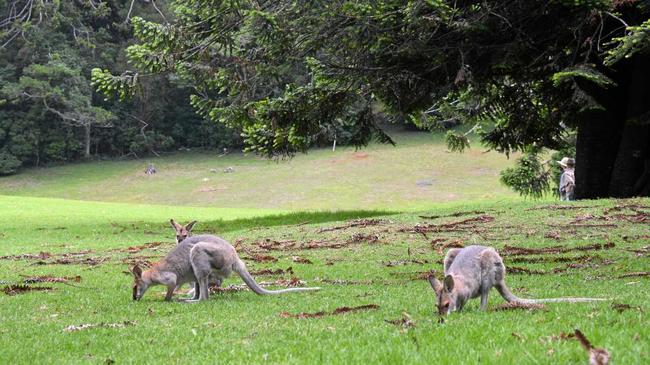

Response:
(0, 132), (518, 210)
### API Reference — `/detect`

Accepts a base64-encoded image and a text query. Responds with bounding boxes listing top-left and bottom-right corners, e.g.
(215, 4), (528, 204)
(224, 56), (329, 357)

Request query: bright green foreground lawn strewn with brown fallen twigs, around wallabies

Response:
(0, 197), (650, 364)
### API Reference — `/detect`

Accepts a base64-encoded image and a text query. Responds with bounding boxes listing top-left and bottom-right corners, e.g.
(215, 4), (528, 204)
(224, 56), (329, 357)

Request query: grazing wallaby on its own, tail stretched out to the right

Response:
(429, 246), (606, 314)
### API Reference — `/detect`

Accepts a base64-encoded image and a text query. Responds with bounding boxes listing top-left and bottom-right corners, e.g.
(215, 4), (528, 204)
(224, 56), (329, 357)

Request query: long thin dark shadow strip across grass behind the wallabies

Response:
(196, 210), (399, 233)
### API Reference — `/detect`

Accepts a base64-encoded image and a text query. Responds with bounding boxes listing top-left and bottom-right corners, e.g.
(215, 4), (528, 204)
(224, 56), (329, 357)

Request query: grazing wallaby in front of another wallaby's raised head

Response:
(131, 235), (320, 301)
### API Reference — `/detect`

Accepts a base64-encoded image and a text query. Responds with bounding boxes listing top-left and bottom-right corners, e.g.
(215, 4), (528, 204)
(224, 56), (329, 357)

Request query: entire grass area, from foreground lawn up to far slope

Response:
(0, 132), (650, 364)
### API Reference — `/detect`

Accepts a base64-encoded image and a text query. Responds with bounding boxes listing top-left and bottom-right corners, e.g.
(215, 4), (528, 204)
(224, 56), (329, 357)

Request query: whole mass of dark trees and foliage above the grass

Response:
(0, 0), (650, 198)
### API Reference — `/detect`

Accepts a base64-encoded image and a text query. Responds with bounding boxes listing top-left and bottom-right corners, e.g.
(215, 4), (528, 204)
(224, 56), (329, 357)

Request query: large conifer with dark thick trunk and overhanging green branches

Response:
(94, 0), (650, 198)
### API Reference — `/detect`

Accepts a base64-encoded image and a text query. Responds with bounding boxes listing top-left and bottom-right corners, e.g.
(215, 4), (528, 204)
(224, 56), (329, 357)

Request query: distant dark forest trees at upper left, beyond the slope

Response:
(0, 0), (241, 175)
